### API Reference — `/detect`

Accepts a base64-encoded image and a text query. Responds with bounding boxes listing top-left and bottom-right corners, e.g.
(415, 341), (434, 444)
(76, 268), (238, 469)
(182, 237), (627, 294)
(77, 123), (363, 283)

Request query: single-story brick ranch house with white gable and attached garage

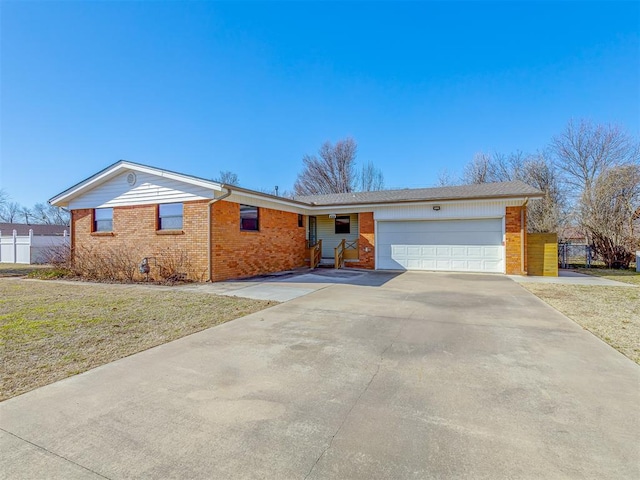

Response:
(49, 161), (542, 281)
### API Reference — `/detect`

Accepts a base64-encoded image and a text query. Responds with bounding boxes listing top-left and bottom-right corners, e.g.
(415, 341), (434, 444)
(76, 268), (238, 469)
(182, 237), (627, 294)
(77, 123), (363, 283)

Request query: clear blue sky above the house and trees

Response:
(0, 0), (640, 206)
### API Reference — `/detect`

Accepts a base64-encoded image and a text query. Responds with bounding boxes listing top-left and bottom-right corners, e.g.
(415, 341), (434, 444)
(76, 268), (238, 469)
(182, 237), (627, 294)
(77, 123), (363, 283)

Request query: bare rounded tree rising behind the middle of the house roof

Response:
(293, 138), (358, 195)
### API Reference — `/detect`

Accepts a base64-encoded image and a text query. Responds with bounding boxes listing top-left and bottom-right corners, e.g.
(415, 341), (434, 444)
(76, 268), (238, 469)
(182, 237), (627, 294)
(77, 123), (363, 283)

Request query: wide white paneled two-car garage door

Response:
(376, 218), (504, 273)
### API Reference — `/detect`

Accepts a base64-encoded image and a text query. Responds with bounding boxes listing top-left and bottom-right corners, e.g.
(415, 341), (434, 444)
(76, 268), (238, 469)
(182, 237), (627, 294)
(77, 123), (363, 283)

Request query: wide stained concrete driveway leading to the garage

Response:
(0, 273), (640, 479)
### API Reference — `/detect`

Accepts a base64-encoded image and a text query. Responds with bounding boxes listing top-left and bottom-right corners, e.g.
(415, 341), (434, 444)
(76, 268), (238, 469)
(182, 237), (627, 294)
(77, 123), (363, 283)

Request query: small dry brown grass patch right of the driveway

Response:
(522, 282), (640, 364)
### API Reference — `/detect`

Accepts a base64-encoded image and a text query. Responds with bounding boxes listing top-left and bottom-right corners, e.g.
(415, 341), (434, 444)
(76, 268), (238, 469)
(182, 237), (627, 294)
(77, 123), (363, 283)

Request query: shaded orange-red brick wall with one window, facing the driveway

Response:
(212, 201), (307, 281)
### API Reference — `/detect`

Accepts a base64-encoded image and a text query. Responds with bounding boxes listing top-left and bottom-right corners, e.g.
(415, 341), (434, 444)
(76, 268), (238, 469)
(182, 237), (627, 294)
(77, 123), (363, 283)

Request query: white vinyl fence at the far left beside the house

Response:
(0, 230), (69, 263)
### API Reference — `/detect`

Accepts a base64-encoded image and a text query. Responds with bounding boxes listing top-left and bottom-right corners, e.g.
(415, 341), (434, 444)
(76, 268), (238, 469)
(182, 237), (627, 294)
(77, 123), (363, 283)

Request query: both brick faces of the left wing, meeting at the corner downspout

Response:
(72, 200), (307, 281)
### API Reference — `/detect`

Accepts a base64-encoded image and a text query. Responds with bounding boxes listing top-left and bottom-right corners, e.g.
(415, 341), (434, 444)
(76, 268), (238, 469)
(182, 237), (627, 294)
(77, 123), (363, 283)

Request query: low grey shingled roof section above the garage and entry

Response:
(294, 180), (543, 206)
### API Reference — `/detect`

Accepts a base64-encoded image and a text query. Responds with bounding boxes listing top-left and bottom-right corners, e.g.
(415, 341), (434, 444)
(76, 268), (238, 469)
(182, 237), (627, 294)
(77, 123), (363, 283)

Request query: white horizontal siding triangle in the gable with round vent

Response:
(69, 172), (213, 210)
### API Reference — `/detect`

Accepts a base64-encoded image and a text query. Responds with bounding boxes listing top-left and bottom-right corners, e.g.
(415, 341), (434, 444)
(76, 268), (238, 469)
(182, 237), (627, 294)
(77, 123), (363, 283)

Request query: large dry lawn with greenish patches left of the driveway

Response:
(0, 278), (275, 399)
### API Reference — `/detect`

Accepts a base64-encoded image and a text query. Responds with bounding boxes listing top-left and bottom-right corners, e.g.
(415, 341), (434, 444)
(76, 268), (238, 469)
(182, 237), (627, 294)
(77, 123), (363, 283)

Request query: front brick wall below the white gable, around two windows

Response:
(71, 200), (208, 281)
